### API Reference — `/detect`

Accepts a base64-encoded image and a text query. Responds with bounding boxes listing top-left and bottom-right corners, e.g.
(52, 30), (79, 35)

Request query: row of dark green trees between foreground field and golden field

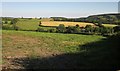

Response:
(36, 24), (120, 35)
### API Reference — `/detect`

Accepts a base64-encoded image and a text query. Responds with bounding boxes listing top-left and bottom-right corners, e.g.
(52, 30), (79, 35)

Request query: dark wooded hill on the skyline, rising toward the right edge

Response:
(51, 13), (120, 25)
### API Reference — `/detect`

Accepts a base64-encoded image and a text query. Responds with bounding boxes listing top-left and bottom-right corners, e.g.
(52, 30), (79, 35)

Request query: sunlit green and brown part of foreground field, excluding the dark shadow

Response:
(2, 30), (105, 69)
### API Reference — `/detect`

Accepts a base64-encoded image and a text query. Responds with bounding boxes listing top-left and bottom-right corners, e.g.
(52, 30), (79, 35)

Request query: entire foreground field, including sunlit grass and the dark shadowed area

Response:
(2, 30), (119, 69)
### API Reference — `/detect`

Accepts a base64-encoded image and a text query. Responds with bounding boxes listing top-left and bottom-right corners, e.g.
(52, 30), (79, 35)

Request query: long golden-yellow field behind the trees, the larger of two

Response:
(42, 21), (95, 27)
